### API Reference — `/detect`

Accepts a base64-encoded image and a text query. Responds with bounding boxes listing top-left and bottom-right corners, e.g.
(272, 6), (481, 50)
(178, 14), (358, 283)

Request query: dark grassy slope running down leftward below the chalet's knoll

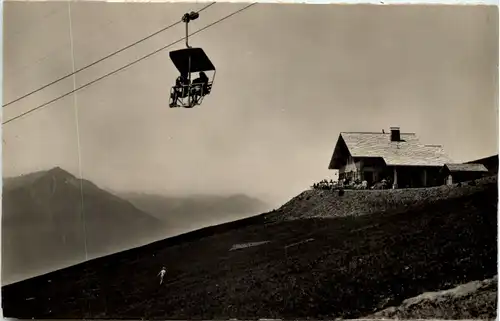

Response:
(2, 176), (497, 319)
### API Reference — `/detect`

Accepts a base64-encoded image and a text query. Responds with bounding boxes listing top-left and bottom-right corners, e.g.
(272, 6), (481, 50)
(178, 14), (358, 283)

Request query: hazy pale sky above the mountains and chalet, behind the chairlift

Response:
(3, 2), (498, 202)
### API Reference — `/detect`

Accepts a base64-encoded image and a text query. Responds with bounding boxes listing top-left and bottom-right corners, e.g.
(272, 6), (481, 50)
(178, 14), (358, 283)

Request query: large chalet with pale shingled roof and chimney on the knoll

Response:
(328, 127), (451, 188)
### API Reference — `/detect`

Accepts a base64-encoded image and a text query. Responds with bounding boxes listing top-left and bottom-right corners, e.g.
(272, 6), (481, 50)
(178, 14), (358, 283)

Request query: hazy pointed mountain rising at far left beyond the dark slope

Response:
(2, 168), (165, 284)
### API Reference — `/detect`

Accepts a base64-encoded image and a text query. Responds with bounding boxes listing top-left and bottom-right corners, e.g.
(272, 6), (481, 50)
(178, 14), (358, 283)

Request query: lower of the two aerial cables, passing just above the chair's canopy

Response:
(2, 2), (257, 125)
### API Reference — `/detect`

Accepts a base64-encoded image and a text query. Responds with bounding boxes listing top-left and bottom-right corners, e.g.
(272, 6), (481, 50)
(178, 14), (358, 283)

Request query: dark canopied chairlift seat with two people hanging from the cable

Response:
(170, 48), (216, 108)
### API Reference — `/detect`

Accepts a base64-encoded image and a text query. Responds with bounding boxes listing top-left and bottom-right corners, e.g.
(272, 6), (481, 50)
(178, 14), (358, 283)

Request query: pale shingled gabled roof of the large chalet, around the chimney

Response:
(329, 132), (451, 169)
